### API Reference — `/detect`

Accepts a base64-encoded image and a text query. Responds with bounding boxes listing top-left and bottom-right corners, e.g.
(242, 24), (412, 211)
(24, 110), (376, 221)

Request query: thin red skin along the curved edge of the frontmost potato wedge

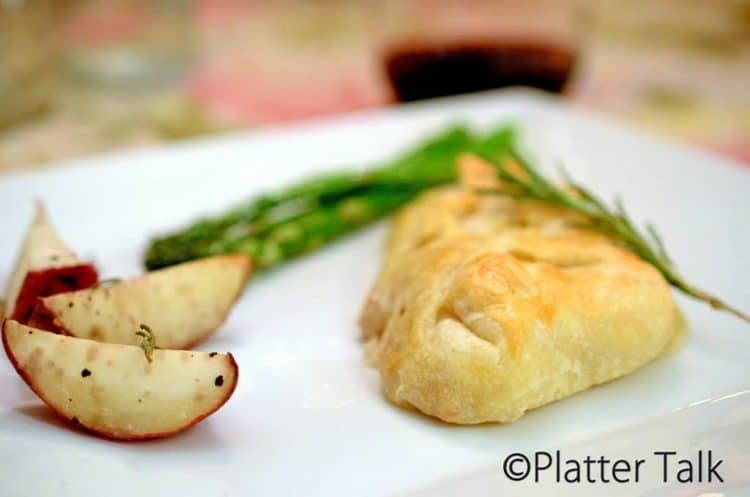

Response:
(2, 319), (240, 442)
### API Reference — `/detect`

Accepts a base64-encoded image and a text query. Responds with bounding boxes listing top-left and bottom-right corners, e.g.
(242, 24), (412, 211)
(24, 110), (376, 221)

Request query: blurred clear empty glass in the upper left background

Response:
(61, 0), (194, 88)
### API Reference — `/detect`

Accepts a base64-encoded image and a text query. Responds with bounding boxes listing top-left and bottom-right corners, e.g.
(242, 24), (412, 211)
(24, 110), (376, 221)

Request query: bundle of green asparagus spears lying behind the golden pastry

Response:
(146, 126), (514, 270)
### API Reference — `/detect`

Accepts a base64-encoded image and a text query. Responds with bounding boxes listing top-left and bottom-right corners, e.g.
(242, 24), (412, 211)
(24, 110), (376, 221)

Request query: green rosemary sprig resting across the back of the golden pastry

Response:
(478, 150), (750, 322)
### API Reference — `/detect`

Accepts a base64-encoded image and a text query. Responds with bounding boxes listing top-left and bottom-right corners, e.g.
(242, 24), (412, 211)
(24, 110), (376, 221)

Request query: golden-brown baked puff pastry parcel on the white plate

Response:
(360, 157), (683, 424)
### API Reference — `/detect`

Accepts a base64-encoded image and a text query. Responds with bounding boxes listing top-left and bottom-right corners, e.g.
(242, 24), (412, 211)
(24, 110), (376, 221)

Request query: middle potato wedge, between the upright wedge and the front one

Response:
(29, 254), (250, 349)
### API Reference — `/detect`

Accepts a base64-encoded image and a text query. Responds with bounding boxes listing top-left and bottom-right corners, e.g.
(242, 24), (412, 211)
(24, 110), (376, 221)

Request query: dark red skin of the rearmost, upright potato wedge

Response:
(8, 264), (99, 324)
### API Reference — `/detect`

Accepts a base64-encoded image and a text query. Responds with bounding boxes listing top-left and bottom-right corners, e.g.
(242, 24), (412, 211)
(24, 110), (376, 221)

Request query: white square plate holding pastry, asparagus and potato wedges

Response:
(0, 92), (750, 497)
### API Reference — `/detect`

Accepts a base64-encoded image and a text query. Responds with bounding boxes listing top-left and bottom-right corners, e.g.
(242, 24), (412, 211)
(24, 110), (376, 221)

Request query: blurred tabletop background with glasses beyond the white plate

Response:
(0, 0), (750, 174)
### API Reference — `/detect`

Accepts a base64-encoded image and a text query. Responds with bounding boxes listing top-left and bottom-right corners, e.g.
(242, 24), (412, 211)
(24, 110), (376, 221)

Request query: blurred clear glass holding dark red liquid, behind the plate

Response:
(383, 0), (580, 101)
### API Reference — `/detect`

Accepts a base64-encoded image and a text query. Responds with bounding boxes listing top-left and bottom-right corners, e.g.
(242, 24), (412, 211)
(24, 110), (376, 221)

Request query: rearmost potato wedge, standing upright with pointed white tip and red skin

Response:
(5, 204), (98, 322)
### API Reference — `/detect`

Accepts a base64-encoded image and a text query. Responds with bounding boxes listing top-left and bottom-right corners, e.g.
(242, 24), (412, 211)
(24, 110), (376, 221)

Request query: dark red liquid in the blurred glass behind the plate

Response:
(384, 40), (575, 102)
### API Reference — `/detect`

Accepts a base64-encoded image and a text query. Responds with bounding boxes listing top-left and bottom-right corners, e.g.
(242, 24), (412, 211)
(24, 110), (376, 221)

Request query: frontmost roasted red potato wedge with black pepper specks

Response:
(3, 320), (238, 440)
